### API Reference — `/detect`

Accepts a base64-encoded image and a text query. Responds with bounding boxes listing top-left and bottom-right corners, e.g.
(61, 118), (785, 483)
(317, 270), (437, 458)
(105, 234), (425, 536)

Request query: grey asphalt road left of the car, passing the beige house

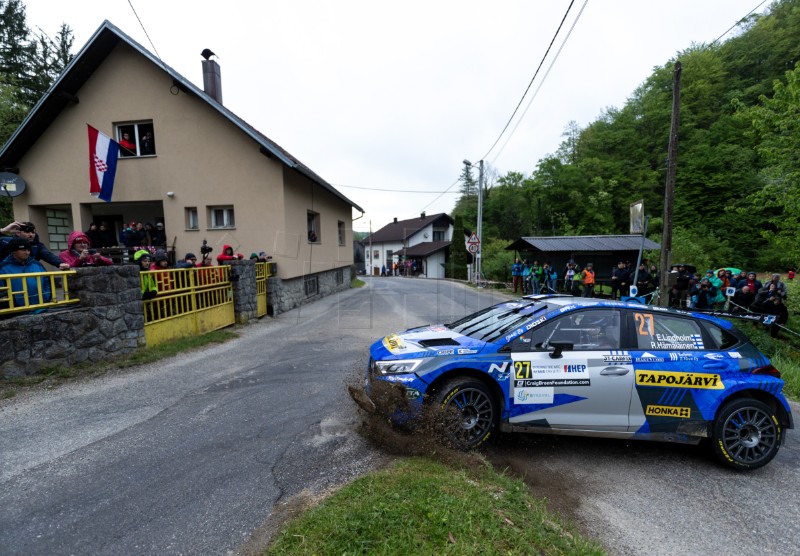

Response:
(0, 278), (506, 555)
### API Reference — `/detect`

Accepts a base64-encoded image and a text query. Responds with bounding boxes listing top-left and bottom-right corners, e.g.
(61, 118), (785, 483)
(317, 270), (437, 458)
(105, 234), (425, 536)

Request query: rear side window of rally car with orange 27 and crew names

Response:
(633, 311), (706, 350)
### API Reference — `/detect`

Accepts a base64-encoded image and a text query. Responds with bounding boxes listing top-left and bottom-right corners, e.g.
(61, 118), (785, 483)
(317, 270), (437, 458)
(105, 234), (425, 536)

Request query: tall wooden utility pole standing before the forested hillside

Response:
(658, 61), (681, 307)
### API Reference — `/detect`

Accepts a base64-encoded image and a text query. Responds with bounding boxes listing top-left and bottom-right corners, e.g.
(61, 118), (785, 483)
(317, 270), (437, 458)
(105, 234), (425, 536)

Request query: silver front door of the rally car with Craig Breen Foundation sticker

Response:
(508, 308), (634, 432)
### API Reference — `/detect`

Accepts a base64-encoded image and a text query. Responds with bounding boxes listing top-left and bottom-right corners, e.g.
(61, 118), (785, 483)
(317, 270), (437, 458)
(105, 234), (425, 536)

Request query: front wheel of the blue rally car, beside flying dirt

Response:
(436, 378), (497, 450)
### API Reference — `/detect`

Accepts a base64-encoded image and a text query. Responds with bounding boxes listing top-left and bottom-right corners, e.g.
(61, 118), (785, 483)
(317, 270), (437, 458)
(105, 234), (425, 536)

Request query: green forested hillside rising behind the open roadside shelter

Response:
(453, 0), (800, 277)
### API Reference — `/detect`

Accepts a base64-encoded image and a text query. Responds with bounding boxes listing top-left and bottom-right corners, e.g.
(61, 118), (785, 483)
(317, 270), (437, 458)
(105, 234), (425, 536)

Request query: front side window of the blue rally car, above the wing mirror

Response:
(511, 309), (620, 351)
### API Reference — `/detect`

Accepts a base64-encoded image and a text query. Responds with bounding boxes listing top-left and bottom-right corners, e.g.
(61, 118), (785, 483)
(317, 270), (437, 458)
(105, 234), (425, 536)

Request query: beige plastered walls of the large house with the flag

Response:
(14, 45), (353, 278)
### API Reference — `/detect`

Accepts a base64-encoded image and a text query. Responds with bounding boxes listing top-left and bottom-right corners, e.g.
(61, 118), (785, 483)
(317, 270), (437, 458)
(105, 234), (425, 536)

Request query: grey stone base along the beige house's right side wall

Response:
(267, 266), (354, 315)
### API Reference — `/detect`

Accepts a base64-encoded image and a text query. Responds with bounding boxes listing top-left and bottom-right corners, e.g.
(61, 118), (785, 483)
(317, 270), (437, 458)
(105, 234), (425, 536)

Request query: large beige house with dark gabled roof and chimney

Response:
(0, 21), (364, 312)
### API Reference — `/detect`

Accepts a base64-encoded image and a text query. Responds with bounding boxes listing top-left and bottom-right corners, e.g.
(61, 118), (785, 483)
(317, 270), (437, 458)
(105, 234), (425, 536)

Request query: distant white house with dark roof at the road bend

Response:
(364, 212), (453, 278)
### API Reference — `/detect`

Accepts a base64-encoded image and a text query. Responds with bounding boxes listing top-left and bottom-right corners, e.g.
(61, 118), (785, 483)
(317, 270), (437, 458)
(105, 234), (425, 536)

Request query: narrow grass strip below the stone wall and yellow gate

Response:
(0, 330), (239, 399)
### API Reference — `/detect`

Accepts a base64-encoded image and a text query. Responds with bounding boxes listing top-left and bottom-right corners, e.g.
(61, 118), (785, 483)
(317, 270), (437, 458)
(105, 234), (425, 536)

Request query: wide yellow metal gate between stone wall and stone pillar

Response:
(139, 265), (235, 346)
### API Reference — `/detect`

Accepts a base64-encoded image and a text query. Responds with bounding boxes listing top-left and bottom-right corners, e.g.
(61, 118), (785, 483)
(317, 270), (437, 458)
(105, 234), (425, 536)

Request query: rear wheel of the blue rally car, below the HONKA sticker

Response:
(711, 399), (782, 470)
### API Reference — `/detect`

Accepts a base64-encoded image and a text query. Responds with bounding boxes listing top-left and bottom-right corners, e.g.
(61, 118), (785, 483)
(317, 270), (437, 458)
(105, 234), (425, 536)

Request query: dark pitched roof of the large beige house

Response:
(0, 20), (364, 213)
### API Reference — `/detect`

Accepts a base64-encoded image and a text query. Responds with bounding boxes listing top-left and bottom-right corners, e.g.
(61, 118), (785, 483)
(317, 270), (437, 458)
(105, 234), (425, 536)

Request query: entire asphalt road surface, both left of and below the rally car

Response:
(0, 278), (800, 556)
